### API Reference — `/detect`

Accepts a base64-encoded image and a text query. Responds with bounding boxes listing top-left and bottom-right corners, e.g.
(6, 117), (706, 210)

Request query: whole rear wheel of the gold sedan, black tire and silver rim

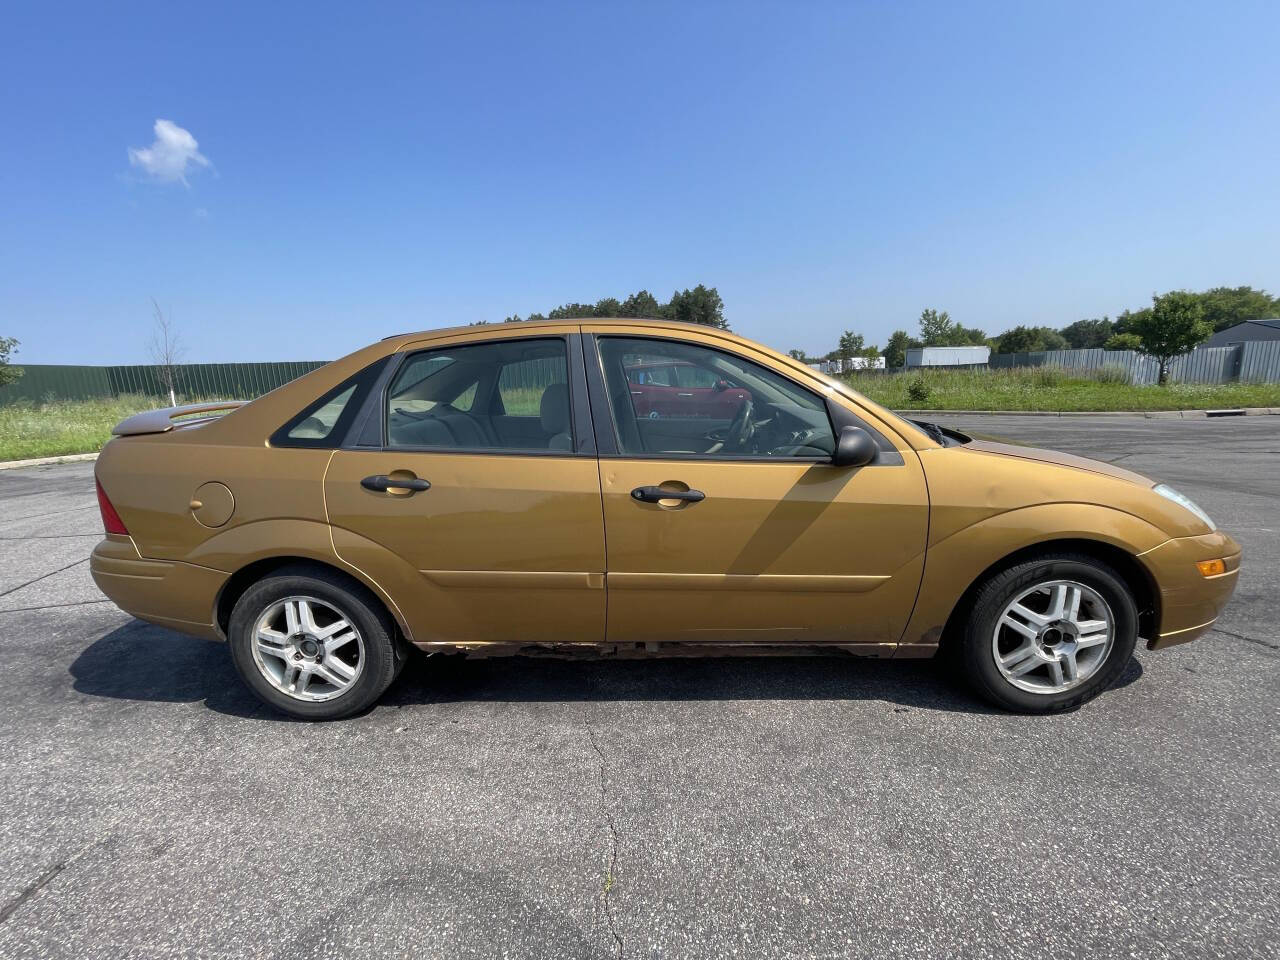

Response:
(227, 566), (404, 721)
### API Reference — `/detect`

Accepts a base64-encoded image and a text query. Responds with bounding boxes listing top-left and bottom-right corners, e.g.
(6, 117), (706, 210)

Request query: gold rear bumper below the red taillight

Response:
(88, 535), (229, 640)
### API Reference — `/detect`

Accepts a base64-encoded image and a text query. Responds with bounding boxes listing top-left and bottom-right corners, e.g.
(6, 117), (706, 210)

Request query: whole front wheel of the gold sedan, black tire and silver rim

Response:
(959, 553), (1138, 713)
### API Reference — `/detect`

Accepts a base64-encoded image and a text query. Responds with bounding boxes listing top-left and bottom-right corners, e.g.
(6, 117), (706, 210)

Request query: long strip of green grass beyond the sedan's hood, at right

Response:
(846, 367), (1280, 412)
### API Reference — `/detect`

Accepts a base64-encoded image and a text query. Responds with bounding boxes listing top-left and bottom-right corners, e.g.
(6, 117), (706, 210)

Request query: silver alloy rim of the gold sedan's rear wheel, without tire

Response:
(253, 596), (365, 703)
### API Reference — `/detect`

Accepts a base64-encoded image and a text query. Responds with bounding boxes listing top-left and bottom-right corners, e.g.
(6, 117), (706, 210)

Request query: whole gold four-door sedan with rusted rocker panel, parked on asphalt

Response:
(92, 320), (1240, 719)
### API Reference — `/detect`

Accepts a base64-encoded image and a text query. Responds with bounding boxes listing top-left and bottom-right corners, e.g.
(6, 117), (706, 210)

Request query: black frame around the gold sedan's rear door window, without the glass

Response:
(363, 333), (595, 460)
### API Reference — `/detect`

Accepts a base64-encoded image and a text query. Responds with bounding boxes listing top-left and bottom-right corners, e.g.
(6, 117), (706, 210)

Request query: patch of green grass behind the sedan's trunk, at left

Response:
(0, 396), (164, 461)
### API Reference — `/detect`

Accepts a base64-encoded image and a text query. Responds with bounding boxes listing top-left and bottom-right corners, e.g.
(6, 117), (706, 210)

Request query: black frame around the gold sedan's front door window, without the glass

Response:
(582, 332), (905, 467)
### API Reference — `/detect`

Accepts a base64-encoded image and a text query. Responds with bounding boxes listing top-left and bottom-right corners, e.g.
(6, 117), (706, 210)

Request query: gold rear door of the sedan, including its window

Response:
(317, 326), (605, 645)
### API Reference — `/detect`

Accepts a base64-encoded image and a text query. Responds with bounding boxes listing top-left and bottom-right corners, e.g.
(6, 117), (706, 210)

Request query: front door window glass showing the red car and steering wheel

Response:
(596, 337), (836, 460)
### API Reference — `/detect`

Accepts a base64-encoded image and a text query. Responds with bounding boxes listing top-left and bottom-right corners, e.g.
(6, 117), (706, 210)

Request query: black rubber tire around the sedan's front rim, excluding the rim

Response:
(963, 557), (1138, 713)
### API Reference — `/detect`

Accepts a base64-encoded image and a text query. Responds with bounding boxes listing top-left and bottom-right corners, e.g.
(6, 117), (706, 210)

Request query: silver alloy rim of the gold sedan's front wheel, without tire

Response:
(991, 580), (1116, 695)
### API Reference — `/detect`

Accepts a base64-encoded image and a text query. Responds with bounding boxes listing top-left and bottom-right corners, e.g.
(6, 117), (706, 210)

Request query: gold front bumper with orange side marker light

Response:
(1140, 530), (1240, 650)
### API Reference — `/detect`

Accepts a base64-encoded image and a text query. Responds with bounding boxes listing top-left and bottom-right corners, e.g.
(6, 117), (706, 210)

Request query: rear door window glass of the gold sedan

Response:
(385, 337), (573, 453)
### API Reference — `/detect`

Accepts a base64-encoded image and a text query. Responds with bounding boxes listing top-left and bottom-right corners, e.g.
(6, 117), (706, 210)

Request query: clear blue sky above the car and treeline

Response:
(0, 1), (1280, 364)
